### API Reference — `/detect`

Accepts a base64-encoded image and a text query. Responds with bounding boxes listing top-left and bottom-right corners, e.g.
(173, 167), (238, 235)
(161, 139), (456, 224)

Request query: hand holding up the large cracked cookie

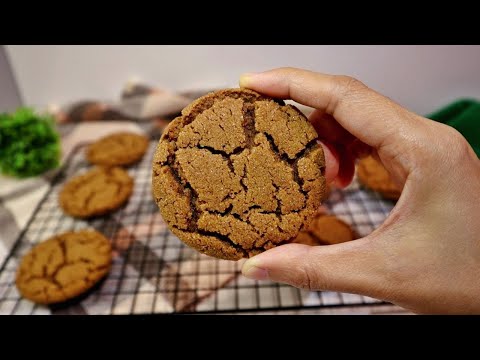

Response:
(240, 68), (480, 314)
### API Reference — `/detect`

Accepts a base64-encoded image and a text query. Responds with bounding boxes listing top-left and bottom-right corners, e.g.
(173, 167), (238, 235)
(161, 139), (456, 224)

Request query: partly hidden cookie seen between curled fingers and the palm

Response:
(357, 156), (401, 200)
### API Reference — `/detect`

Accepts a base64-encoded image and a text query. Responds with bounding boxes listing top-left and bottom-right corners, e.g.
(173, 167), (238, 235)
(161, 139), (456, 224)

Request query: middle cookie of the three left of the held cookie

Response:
(59, 167), (133, 218)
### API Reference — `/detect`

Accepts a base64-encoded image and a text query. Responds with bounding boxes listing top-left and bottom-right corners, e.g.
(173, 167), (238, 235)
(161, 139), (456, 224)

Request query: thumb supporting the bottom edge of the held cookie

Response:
(242, 237), (388, 298)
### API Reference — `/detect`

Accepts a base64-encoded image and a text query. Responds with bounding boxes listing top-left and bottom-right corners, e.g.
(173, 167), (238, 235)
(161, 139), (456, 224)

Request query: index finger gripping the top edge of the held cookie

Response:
(240, 68), (416, 148)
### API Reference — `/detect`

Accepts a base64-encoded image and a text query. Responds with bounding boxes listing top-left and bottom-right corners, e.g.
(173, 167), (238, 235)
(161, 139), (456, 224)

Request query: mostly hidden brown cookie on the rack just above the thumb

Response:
(294, 215), (356, 246)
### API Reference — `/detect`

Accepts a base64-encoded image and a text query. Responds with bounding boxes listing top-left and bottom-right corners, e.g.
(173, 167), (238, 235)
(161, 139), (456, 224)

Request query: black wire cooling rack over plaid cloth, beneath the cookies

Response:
(0, 141), (393, 314)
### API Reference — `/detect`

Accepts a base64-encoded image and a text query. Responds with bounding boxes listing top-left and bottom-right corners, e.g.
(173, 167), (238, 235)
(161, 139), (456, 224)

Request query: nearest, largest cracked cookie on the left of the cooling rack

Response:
(16, 230), (112, 304)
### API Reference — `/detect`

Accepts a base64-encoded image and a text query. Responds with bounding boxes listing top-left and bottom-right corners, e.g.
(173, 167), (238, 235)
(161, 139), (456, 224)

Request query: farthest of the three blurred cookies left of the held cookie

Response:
(85, 132), (148, 166)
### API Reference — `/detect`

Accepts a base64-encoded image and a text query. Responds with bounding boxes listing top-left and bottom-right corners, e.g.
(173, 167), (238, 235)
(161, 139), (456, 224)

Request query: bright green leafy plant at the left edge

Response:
(0, 107), (61, 178)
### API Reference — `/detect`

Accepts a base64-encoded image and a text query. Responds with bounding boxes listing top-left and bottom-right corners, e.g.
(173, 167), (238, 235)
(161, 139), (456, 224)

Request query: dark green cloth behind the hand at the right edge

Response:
(426, 99), (480, 158)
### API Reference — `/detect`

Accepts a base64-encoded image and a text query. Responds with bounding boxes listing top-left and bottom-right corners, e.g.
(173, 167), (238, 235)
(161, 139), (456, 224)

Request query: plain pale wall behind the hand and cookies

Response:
(7, 45), (480, 114)
